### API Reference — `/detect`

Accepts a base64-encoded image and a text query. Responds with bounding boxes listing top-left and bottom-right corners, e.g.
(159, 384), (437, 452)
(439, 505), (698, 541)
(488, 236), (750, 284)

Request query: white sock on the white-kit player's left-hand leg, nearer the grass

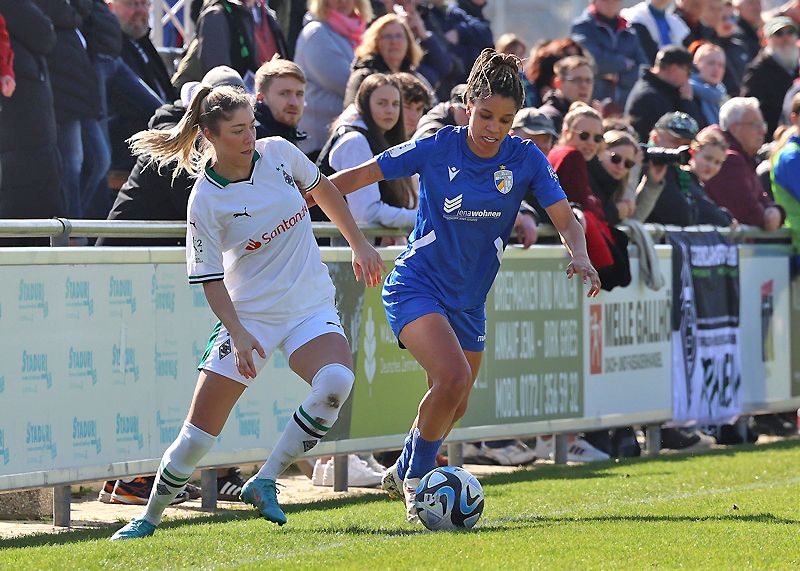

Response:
(143, 422), (217, 525)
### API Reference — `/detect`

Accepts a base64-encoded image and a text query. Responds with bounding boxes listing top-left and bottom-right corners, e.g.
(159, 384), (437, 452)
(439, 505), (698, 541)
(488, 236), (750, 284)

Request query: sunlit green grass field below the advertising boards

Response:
(0, 440), (800, 570)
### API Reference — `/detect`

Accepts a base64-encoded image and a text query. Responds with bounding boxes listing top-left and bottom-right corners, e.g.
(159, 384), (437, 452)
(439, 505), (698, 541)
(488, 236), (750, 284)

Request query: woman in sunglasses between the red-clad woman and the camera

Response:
(588, 131), (639, 225)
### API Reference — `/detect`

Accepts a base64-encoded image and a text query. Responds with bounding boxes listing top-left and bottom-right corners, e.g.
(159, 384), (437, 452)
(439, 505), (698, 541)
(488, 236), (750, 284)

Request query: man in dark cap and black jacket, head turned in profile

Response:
(625, 46), (705, 141)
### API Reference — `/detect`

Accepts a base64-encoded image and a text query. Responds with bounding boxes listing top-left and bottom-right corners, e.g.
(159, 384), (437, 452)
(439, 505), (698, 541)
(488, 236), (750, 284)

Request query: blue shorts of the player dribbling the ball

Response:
(382, 274), (486, 353)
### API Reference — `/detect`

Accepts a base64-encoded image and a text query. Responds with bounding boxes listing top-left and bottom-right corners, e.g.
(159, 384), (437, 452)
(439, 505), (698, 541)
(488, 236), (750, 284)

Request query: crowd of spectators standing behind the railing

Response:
(0, 0), (800, 470)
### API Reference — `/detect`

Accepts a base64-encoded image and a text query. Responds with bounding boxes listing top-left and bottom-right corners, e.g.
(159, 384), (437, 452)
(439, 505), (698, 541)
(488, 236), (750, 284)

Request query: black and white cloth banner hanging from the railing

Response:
(668, 232), (742, 425)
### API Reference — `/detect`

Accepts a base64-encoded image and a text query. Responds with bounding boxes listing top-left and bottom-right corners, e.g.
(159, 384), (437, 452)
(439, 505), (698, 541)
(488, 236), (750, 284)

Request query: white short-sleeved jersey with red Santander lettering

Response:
(186, 137), (335, 319)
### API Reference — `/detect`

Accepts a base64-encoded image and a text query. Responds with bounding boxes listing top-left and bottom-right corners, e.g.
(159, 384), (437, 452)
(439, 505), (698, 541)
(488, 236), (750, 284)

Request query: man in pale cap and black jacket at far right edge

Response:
(741, 16), (800, 140)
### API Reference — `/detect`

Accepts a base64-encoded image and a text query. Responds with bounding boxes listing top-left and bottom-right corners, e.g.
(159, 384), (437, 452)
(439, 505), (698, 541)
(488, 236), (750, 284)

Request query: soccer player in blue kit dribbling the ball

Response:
(331, 48), (600, 521)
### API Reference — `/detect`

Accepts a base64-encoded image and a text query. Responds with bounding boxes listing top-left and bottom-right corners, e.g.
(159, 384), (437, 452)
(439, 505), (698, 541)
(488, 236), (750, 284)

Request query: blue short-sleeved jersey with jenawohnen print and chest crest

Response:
(377, 127), (566, 310)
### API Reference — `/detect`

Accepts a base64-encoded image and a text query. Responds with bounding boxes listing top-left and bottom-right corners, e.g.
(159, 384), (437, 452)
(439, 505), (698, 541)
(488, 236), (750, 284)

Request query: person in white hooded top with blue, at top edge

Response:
(620, 0), (689, 65)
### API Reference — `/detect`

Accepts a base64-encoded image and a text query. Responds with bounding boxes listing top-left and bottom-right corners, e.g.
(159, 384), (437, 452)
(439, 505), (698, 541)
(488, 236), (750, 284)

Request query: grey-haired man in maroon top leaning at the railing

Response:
(706, 97), (782, 230)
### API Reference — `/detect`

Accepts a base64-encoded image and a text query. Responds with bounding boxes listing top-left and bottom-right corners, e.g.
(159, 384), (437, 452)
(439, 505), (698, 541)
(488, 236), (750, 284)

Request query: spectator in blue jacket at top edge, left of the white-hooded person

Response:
(570, 0), (647, 108)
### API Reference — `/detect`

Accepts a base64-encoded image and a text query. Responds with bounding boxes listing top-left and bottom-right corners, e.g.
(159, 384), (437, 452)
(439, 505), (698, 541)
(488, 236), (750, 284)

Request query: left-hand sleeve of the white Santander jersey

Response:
(186, 195), (225, 284)
